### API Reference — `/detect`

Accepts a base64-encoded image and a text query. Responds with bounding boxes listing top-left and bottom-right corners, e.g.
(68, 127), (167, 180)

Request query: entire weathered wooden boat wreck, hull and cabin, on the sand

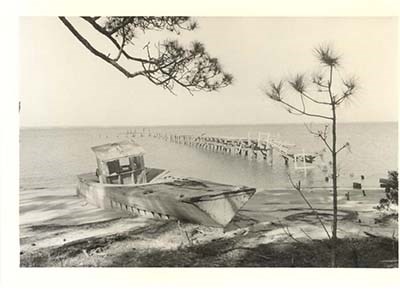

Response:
(77, 140), (256, 227)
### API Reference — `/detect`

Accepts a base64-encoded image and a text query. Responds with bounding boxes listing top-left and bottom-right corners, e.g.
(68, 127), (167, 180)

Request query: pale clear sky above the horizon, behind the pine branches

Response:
(19, 17), (398, 127)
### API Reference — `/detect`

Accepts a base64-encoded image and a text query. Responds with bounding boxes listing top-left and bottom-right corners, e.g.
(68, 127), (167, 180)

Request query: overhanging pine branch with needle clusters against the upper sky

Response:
(59, 16), (233, 93)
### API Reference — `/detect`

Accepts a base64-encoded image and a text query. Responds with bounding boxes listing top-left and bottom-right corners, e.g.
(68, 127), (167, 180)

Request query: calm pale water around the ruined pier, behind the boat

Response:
(20, 123), (398, 189)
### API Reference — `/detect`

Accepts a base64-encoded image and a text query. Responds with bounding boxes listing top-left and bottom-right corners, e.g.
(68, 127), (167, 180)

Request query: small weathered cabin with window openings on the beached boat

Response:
(92, 140), (147, 184)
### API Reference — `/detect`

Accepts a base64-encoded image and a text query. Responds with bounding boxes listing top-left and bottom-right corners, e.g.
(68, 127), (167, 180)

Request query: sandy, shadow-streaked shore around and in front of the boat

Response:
(20, 187), (398, 267)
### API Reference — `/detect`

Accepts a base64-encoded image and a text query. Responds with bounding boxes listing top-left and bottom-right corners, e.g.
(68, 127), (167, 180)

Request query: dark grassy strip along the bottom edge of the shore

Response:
(21, 234), (398, 268)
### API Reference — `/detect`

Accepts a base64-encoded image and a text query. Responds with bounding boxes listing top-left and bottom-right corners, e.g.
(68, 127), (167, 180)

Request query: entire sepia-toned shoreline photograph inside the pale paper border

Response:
(2, 0), (399, 290)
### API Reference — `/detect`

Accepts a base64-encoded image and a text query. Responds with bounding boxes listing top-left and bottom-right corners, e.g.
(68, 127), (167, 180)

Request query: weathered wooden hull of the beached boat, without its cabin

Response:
(77, 174), (256, 227)
